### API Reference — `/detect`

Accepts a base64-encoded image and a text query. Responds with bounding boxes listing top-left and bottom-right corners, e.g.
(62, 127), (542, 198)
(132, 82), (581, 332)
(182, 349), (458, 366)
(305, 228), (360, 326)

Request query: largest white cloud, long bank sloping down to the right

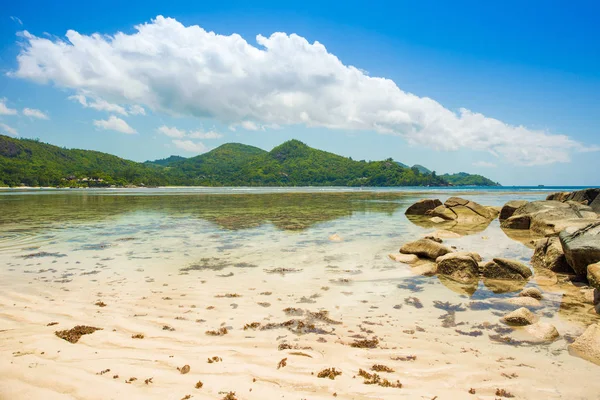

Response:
(10, 16), (598, 165)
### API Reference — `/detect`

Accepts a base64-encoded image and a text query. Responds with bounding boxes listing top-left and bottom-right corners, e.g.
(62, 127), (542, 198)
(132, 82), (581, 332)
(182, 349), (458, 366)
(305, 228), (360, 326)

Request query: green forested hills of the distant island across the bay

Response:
(0, 135), (500, 187)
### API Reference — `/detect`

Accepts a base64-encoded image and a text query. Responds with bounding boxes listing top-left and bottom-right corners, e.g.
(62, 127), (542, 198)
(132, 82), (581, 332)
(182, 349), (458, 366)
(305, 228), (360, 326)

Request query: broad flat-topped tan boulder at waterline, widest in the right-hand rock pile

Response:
(501, 200), (598, 236)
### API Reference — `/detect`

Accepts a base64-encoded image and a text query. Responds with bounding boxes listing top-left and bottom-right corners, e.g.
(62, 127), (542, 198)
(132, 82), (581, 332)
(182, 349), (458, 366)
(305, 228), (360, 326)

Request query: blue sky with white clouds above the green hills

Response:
(0, 0), (600, 186)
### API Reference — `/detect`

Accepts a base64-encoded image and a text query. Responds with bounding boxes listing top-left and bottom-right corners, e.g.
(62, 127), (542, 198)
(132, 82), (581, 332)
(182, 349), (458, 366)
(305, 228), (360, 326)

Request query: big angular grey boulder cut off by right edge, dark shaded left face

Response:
(558, 221), (600, 276)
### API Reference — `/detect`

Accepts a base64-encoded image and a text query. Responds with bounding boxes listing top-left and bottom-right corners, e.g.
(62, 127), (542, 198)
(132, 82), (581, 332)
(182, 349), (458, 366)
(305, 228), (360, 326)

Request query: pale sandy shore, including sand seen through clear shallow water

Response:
(0, 191), (600, 399)
